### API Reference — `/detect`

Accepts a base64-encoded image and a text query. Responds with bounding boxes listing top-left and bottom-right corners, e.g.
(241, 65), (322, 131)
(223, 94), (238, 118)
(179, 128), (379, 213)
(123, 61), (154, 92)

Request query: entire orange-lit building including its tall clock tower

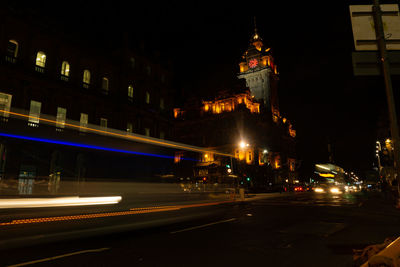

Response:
(174, 25), (298, 190)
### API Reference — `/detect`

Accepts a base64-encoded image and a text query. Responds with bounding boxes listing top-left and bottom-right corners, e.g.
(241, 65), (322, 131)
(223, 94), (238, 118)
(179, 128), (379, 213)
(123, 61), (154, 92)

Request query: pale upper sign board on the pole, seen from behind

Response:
(350, 4), (400, 51)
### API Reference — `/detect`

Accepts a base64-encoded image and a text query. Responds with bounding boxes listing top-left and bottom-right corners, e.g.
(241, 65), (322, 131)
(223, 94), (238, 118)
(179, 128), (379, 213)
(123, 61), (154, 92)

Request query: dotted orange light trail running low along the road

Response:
(0, 200), (234, 226)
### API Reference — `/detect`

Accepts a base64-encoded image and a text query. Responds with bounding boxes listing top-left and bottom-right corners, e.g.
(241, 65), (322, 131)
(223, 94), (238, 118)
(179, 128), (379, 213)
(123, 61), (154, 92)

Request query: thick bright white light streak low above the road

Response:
(0, 196), (122, 209)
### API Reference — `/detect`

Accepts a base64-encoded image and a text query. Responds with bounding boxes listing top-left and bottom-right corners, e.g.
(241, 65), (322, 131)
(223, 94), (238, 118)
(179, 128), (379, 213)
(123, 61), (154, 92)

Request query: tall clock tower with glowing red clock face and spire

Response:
(238, 23), (279, 117)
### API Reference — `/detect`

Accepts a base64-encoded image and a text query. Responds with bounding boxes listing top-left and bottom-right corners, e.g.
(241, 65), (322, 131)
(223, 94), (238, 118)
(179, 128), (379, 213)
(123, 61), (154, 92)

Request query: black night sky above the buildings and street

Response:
(6, 1), (400, 178)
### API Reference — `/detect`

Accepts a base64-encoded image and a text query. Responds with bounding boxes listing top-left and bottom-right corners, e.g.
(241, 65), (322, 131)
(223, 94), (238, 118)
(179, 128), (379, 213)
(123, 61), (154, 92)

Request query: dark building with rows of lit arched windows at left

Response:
(0, 8), (177, 193)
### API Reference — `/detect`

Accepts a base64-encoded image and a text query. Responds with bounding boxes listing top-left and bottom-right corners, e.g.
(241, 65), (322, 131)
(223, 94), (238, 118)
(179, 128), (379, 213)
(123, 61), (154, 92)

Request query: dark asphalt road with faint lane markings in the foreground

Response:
(0, 192), (400, 266)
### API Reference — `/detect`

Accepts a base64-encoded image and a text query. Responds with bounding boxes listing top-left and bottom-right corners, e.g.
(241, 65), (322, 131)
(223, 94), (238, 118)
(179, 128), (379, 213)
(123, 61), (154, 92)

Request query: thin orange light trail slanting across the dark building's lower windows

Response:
(0, 109), (234, 157)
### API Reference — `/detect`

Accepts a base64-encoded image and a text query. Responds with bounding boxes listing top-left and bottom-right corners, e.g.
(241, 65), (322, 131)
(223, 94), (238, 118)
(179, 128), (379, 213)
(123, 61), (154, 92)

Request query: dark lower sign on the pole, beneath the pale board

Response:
(352, 51), (400, 76)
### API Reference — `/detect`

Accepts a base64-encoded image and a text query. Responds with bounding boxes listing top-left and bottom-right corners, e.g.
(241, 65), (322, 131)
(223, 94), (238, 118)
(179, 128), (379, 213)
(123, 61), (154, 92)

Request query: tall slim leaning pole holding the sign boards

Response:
(372, 0), (400, 201)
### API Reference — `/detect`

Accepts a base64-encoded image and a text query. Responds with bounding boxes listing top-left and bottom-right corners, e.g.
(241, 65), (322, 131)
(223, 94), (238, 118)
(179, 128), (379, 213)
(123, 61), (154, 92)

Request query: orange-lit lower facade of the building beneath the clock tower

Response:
(174, 90), (298, 189)
